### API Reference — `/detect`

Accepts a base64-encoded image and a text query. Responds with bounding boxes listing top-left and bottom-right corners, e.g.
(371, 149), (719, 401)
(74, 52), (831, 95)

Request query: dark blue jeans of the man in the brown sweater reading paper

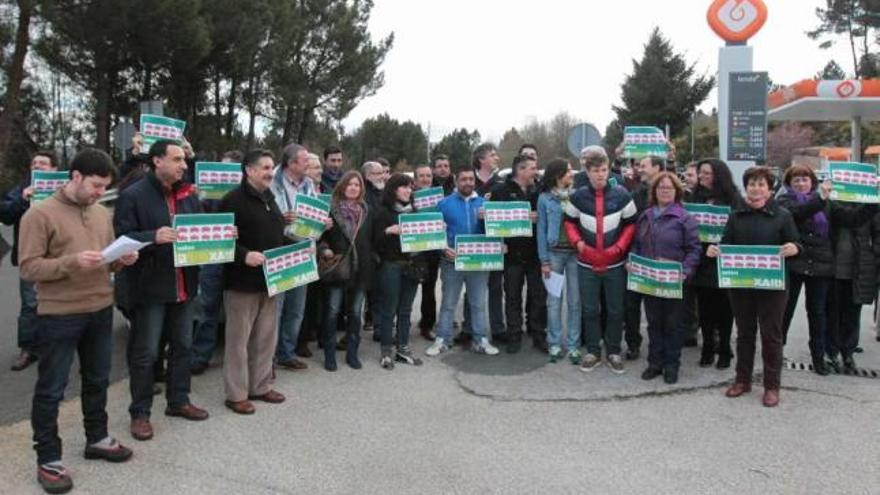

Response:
(31, 306), (113, 464)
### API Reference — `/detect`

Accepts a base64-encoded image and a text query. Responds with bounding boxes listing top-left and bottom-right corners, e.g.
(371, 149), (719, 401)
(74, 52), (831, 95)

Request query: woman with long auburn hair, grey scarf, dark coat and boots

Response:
(318, 172), (375, 371)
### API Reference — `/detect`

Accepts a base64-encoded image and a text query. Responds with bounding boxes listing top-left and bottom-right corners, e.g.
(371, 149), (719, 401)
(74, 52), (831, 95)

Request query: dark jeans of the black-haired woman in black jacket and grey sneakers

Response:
(377, 261), (419, 351)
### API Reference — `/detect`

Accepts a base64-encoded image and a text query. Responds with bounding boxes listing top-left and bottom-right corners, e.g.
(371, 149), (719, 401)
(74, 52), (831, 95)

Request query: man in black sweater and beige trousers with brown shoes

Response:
(219, 150), (285, 414)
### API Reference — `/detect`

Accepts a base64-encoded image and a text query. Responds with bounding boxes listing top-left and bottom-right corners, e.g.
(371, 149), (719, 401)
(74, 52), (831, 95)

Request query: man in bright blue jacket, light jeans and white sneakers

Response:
(425, 167), (498, 356)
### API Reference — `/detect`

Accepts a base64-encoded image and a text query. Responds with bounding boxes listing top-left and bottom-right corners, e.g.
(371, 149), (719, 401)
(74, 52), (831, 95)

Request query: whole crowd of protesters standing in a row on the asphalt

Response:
(0, 135), (880, 493)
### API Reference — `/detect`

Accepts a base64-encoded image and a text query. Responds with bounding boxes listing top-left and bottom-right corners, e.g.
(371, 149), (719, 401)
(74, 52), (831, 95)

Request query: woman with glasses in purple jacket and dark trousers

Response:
(633, 172), (701, 384)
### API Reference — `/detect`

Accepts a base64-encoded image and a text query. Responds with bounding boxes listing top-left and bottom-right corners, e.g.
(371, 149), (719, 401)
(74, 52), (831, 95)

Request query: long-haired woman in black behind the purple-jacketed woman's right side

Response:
(691, 159), (742, 369)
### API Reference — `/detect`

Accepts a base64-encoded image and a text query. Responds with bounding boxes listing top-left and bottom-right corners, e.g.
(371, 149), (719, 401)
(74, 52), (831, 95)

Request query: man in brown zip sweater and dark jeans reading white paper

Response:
(19, 149), (138, 493)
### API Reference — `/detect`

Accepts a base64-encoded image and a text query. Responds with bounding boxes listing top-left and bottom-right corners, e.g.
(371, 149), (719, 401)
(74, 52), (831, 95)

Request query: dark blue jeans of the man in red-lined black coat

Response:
(128, 300), (194, 418)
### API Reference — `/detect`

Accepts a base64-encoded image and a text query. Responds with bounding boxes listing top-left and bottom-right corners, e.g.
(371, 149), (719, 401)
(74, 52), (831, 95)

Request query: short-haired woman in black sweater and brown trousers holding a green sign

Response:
(706, 167), (802, 407)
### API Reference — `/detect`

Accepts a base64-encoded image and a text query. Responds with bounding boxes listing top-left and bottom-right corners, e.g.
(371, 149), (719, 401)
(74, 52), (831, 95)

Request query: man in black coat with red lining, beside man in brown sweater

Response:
(113, 140), (208, 440)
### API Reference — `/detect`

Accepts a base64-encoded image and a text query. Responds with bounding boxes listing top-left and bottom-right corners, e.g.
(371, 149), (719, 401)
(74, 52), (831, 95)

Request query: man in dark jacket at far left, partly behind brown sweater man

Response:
(0, 151), (58, 371)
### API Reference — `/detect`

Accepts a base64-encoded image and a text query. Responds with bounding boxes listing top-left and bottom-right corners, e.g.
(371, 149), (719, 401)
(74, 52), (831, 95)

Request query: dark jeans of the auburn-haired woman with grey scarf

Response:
(322, 285), (367, 363)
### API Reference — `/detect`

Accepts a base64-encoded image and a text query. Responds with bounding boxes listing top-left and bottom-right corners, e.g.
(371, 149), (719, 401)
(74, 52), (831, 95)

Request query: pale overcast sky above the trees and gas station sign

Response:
(343, 0), (852, 141)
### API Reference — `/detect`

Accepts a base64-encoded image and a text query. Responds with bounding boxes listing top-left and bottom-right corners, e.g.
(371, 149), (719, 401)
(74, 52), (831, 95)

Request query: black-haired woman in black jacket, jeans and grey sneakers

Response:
(373, 174), (428, 370)
